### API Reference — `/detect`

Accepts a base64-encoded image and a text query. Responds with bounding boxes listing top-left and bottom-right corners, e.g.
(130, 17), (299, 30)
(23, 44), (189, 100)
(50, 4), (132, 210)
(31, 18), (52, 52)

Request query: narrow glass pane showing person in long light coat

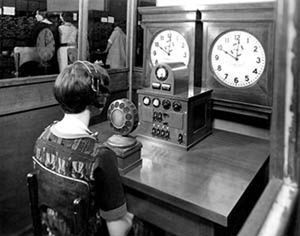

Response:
(88, 0), (127, 69)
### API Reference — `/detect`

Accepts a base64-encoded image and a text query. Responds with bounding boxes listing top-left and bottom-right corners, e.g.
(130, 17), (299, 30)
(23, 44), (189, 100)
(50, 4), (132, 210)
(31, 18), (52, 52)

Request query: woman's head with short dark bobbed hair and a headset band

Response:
(54, 61), (109, 114)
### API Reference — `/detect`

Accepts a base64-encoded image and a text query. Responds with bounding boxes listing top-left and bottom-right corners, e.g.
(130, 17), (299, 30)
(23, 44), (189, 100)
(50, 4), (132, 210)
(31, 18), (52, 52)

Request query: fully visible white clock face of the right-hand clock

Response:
(210, 30), (266, 88)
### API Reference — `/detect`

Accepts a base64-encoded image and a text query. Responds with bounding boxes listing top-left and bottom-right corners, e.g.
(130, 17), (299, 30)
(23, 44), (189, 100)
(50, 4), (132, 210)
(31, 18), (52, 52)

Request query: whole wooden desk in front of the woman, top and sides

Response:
(92, 123), (269, 236)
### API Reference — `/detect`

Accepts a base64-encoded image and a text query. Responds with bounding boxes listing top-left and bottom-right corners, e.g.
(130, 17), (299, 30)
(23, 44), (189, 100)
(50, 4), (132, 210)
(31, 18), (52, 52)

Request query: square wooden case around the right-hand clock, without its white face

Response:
(199, 2), (275, 120)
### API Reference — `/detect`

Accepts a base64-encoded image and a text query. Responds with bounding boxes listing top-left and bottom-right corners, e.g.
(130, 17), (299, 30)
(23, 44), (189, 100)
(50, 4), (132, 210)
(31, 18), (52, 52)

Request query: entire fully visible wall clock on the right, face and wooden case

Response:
(200, 2), (275, 120)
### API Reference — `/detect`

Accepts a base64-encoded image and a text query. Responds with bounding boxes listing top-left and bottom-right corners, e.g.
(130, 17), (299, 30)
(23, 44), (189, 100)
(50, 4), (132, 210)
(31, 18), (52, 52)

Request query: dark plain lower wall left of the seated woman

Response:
(0, 105), (62, 235)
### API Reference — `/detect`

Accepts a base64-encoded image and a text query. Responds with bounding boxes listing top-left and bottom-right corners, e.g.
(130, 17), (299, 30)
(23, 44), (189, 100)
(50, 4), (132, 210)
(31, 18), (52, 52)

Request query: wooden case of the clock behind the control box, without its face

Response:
(138, 7), (202, 88)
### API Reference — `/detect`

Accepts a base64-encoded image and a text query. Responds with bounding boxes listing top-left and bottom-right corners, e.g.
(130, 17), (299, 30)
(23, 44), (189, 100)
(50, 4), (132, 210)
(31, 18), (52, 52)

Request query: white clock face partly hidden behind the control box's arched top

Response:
(150, 30), (190, 65)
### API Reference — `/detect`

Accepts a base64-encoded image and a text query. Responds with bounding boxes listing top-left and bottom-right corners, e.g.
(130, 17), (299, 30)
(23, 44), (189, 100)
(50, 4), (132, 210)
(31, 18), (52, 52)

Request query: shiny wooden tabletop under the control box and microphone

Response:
(92, 123), (269, 226)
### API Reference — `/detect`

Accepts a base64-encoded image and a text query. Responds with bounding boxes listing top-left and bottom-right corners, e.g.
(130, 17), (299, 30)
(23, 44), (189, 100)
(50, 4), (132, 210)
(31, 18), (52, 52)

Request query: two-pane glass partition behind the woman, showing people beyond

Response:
(0, 0), (127, 79)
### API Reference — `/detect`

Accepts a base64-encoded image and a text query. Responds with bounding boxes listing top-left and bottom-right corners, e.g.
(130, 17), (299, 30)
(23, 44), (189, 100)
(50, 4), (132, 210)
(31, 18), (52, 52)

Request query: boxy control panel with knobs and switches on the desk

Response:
(138, 89), (211, 149)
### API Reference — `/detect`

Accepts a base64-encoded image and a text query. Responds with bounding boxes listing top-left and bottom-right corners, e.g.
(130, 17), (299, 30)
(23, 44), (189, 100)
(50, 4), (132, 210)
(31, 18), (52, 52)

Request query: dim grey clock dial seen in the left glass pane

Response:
(36, 28), (55, 62)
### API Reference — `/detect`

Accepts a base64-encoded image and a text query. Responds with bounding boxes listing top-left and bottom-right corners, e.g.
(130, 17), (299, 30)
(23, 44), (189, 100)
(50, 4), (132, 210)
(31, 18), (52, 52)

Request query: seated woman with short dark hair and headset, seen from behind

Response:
(31, 61), (133, 236)
